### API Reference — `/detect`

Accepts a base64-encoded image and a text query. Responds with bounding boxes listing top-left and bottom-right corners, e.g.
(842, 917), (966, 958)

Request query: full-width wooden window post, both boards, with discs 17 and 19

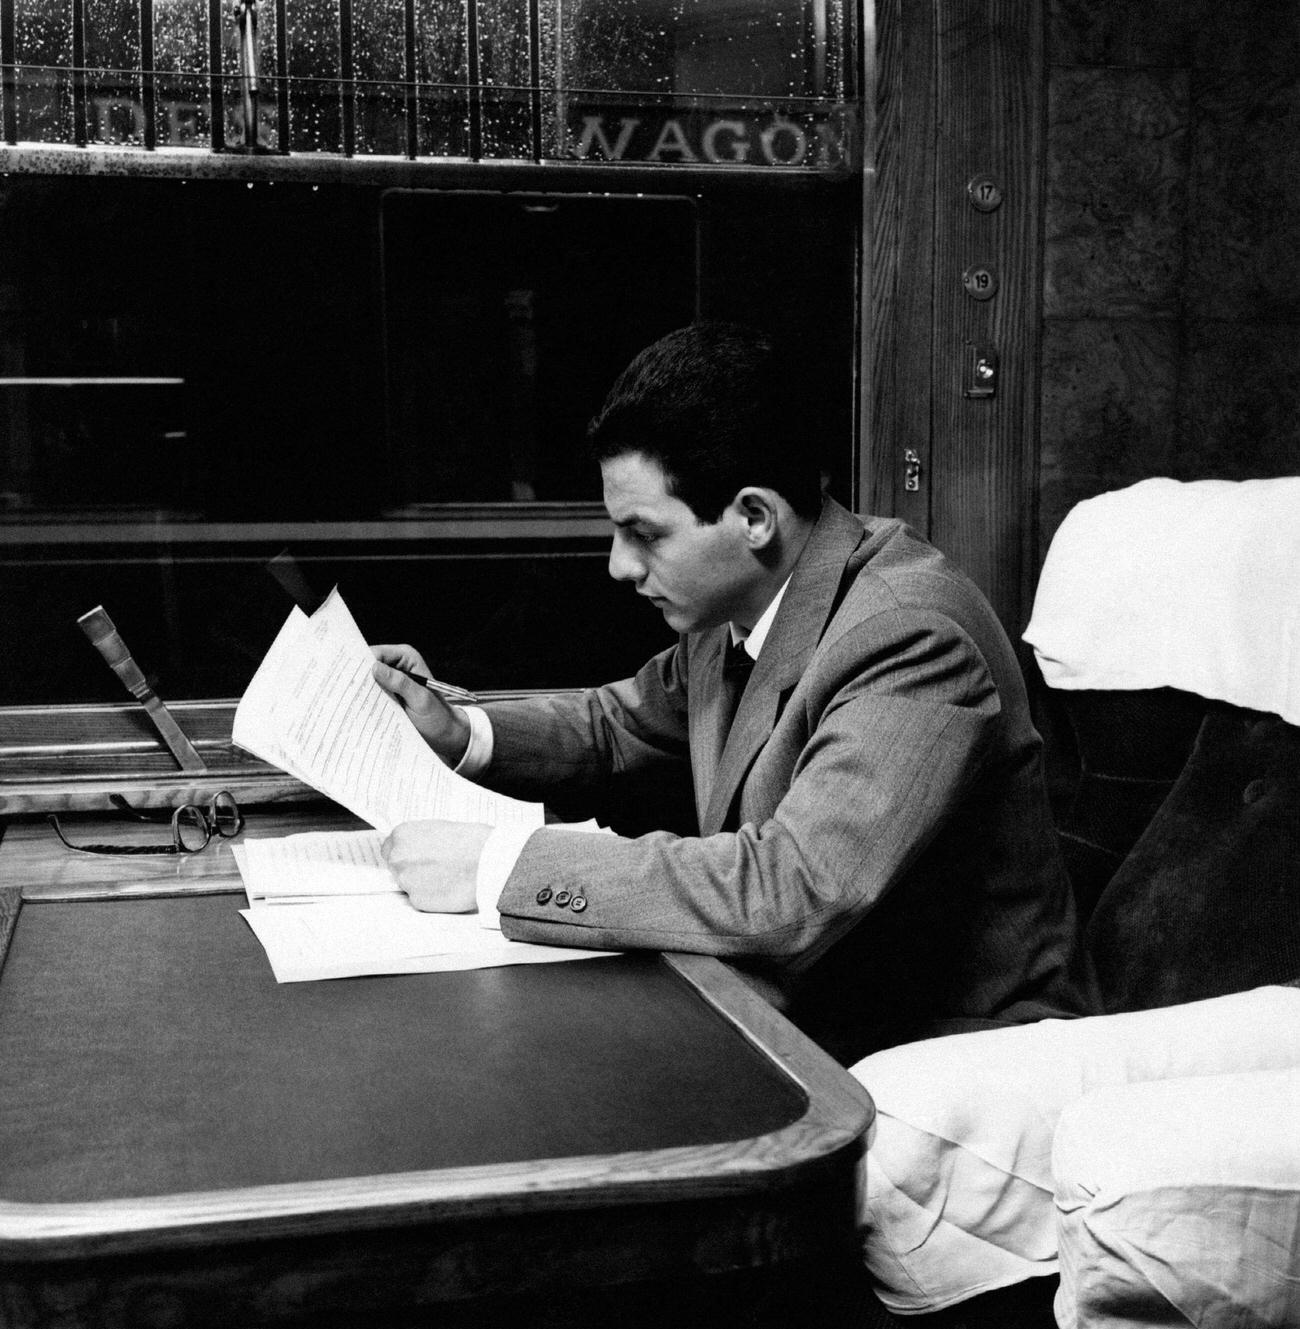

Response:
(865, 0), (1043, 634)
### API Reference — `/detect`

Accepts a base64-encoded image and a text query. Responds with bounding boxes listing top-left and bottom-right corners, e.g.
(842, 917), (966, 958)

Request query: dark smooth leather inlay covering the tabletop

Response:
(0, 894), (804, 1203)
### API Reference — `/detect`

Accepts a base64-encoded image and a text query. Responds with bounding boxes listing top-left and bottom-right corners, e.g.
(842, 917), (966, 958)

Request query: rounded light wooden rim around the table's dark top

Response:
(0, 888), (875, 1263)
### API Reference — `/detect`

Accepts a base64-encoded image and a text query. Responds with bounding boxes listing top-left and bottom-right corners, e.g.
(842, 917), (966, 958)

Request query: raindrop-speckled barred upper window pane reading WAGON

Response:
(0, 0), (853, 171)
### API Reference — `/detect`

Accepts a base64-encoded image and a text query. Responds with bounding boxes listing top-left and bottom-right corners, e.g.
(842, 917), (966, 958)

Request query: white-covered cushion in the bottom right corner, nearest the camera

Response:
(1053, 1069), (1300, 1329)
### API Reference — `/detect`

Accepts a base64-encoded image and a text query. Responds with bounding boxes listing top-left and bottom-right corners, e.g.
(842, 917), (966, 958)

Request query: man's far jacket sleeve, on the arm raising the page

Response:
(480, 638), (694, 831)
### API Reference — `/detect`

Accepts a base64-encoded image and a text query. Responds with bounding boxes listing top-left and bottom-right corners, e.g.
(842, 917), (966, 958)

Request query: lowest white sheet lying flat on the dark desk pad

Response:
(239, 893), (611, 983)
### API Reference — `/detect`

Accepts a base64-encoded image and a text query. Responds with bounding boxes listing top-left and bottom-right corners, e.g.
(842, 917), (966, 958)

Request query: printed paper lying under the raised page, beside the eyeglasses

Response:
(230, 831), (401, 906)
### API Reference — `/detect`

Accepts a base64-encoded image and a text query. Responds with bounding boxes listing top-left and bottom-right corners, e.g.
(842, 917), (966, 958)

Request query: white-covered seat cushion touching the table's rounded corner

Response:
(852, 987), (1300, 1314)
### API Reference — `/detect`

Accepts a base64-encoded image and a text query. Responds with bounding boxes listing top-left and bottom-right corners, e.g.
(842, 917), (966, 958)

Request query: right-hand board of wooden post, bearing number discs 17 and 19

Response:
(930, 0), (1045, 635)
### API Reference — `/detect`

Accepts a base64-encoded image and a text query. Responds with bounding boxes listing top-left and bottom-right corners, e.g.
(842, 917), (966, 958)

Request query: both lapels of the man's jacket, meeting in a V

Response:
(690, 500), (864, 835)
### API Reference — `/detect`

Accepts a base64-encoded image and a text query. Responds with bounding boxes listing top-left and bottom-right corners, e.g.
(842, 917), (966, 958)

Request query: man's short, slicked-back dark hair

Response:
(588, 323), (821, 522)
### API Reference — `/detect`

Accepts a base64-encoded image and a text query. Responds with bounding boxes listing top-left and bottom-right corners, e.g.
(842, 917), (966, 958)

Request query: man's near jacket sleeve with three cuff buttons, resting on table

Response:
(500, 610), (1000, 969)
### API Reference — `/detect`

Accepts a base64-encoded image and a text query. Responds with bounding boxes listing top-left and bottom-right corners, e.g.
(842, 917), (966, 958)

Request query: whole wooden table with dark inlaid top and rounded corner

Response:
(0, 811), (872, 1329)
